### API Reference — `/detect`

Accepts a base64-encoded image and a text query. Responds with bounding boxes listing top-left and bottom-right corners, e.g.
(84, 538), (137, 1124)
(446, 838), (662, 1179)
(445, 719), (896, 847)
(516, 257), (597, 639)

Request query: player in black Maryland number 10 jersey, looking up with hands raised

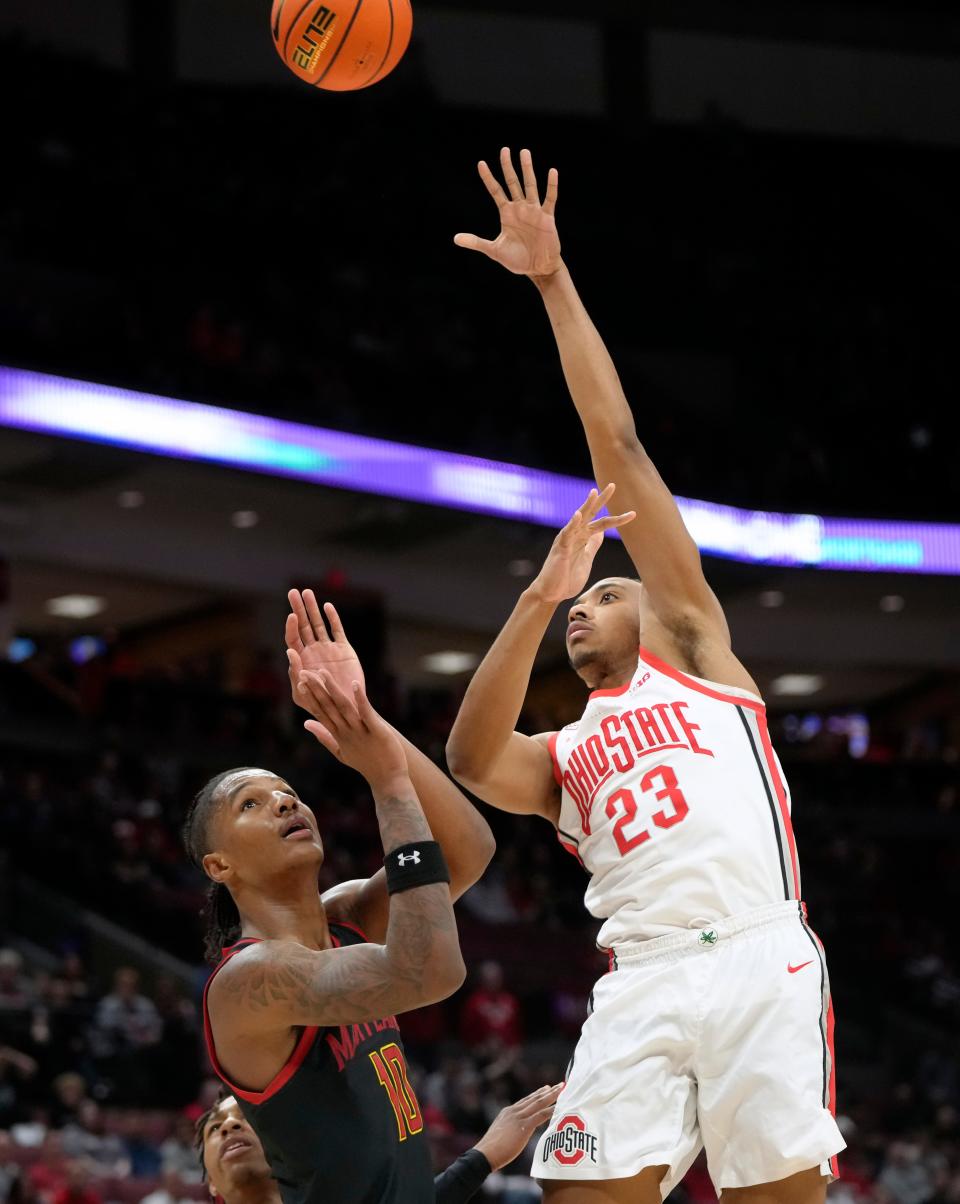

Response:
(184, 594), (493, 1204)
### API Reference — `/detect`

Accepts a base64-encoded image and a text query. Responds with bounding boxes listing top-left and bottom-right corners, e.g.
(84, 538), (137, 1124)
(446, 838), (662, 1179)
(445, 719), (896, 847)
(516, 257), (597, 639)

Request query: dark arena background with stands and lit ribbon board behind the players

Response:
(0, 0), (960, 1204)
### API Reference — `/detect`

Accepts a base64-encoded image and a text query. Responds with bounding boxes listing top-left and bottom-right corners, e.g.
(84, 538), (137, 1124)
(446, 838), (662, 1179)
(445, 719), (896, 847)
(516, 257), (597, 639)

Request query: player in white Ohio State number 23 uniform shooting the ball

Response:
(447, 149), (844, 1204)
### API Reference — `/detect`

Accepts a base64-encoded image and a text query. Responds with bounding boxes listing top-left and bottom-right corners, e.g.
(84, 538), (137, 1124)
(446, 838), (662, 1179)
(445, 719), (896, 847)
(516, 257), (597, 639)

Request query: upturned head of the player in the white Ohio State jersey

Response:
(566, 577), (643, 687)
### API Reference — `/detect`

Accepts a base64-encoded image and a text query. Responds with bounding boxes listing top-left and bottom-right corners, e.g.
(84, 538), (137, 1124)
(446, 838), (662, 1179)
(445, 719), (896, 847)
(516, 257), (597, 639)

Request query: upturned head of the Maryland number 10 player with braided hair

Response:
(183, 766), (323, 961)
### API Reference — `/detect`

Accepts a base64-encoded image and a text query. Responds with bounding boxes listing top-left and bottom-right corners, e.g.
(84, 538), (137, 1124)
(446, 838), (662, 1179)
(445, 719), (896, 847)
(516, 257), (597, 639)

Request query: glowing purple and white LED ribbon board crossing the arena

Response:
(0, 367), (960, 574)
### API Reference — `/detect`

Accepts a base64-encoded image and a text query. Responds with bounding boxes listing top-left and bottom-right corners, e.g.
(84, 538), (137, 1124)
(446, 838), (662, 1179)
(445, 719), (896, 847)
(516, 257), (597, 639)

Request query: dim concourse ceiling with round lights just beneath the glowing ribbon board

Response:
(0, 431), (960, 706)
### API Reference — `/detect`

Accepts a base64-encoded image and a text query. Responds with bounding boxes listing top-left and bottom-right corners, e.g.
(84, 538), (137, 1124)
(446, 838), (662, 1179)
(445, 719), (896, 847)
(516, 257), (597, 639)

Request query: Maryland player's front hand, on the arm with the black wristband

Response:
(300, 669), (407, 786)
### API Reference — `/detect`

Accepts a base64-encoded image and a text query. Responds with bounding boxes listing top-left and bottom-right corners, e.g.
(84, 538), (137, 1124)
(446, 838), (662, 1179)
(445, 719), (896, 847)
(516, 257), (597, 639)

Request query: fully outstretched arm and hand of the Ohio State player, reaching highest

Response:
(455, 148), (729, 647)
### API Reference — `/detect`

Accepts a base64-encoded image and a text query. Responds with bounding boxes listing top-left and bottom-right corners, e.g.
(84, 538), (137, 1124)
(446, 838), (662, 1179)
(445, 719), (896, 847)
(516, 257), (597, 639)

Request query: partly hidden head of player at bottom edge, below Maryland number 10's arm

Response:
(196, 1096), (273, 1204)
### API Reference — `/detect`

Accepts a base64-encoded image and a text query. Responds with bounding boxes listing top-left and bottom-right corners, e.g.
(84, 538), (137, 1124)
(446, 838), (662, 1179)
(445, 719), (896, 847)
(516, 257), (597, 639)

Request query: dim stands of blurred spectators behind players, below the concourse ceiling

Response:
(0, 651), (960, 1204)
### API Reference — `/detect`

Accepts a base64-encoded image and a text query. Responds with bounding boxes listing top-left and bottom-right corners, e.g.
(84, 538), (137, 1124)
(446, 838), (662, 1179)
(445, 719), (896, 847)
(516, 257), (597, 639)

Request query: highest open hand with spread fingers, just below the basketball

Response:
(453, 147), (561, 276)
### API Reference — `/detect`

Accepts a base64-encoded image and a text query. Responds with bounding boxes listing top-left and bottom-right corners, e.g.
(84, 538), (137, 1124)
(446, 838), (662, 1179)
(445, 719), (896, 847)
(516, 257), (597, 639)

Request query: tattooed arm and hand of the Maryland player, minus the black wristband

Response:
(210, 675), (466, 1038)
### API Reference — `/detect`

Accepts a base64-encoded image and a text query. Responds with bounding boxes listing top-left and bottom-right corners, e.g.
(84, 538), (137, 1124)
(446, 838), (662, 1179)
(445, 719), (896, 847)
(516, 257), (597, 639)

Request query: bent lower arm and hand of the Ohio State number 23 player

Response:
(447, 485), (632, 824)
